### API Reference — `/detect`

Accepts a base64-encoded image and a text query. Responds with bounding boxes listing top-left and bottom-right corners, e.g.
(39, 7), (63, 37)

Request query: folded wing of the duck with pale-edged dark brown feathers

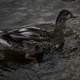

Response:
(2, 27), (48, 41)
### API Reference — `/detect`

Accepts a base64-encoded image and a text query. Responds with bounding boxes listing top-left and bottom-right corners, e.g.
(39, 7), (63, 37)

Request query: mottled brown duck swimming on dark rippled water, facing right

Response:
(0, 9), (76, 62)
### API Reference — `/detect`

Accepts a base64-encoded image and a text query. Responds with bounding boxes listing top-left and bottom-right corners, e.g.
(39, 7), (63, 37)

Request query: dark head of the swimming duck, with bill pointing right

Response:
(56, 9), (76, 25)
